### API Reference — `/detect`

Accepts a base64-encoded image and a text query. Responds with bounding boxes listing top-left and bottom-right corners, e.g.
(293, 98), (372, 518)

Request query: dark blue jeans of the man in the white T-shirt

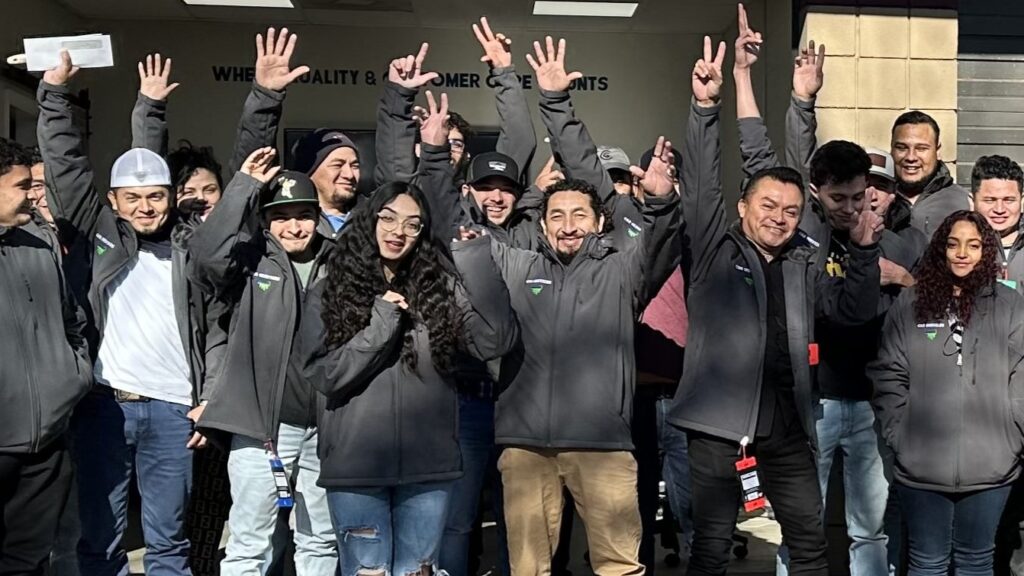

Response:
(74, 386), (193, 576)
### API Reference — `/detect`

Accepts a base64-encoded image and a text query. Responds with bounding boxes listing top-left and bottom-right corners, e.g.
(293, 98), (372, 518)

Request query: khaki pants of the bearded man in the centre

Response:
(498, 448), (644, 576)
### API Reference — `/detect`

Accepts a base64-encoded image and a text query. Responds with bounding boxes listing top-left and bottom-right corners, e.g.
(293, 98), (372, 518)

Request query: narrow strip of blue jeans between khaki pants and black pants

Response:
(657, 398), (693, 537)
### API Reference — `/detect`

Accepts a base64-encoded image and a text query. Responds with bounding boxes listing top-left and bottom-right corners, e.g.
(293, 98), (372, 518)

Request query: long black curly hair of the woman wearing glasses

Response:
(323, 182), (461, 374)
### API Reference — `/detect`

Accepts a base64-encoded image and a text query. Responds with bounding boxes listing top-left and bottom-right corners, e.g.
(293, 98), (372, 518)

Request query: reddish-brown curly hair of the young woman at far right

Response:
(913, 210), (1000, 325)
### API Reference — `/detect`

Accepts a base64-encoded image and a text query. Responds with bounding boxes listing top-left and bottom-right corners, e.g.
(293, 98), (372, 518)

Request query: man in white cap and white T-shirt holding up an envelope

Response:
(38, 51), (205, 576)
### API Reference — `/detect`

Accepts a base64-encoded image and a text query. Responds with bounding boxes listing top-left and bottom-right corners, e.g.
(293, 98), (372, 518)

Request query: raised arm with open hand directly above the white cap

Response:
(131, 54), (179, 156)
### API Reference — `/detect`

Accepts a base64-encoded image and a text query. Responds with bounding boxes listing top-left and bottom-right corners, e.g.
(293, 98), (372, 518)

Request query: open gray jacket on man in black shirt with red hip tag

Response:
(669, 104), (880, 443)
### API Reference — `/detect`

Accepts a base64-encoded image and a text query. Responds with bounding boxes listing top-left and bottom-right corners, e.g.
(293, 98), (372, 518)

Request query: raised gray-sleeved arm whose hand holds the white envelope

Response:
(36, 50), (104, 237)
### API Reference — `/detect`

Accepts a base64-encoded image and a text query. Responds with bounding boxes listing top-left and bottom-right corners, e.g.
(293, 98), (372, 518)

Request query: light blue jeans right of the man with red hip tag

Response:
(776, 399), (890, 576)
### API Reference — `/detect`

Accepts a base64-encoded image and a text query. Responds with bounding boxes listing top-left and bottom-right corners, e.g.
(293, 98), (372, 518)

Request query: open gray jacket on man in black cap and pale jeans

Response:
(188, 172), (334, 441)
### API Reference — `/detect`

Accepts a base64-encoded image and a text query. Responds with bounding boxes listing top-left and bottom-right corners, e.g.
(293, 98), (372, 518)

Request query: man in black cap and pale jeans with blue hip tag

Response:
(188, 149), (338, 576)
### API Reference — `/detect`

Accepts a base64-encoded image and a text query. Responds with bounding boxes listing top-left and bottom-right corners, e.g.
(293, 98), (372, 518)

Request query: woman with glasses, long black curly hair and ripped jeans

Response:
(299, 182), (518, 576)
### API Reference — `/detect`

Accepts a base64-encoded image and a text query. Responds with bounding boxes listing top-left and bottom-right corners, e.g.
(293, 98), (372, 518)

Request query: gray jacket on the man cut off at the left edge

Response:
(0, 223), (92, 454)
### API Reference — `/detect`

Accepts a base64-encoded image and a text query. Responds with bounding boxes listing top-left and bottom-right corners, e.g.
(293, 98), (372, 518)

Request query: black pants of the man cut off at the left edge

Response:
(0, 441), (72, 576)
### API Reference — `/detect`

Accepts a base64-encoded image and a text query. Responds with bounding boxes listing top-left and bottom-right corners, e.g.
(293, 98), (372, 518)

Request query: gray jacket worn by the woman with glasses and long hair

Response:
(298, 237), (519, 487)
